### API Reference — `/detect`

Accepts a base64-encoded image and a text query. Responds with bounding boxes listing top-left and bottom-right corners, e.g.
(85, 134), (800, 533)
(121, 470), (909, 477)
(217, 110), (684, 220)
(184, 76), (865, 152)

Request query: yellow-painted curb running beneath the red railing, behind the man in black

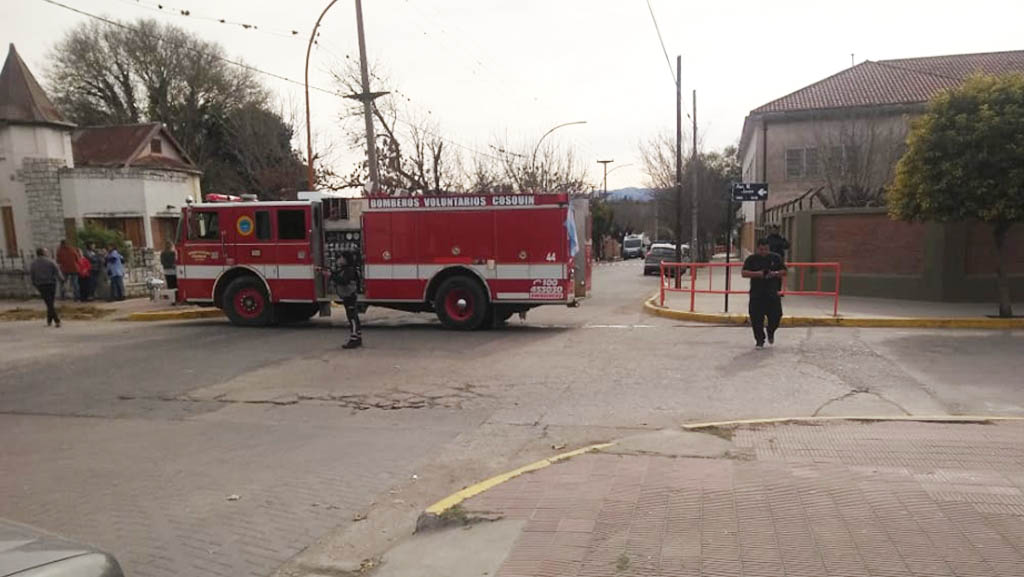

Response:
(643, 295), (1024, 330)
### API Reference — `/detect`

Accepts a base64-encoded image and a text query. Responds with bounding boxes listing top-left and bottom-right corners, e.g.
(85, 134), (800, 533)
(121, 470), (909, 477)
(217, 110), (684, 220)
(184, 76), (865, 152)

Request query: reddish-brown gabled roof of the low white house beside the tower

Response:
(71, 122), (198, 171)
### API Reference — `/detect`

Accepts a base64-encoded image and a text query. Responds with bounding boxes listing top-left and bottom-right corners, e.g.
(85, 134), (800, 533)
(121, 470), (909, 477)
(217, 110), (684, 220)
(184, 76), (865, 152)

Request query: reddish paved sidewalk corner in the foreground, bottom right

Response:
(389, 421), (1024, 577)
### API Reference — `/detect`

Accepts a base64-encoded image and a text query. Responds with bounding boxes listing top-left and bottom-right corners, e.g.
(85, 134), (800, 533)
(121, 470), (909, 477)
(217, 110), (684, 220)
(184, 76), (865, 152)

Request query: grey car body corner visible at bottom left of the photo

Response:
(0, 520), (124, 577)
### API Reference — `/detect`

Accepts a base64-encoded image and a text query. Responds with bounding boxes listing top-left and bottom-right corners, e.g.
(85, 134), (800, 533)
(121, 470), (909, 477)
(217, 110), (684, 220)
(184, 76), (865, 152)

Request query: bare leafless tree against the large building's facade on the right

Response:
(804, 115), (907, 208)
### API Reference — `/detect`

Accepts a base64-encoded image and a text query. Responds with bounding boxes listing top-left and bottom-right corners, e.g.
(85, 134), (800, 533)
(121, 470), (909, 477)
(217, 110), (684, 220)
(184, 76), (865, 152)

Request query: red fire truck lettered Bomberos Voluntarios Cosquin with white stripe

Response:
(176, 193), (590, 329)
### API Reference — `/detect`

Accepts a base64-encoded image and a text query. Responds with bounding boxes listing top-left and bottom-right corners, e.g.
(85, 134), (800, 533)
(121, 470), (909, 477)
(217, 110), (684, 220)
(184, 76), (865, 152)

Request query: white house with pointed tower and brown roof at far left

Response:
(0, 45), (202, 255)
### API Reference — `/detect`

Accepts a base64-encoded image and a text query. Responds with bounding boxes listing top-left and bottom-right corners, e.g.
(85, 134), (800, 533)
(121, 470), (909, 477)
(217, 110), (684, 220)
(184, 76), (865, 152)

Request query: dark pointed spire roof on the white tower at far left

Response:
(0, 44), (74, 126)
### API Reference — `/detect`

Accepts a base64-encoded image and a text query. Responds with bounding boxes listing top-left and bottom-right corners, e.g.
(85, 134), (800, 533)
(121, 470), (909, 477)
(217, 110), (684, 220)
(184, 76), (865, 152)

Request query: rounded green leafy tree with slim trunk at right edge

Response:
(888, 75), (1024, 317)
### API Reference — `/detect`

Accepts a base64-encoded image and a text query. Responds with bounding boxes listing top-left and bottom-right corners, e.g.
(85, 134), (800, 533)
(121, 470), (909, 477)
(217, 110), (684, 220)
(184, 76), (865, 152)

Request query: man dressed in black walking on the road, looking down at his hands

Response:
(742, 239), (786, 348)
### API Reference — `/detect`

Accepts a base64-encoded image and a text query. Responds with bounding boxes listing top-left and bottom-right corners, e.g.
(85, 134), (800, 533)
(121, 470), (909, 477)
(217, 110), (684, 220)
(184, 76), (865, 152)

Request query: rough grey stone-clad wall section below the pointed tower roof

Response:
(17, 158), (65, 251)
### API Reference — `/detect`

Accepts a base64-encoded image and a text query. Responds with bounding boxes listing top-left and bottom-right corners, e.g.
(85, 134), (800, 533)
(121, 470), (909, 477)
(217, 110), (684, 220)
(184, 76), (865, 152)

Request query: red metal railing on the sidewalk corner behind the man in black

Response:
(659, 262), (840, 317)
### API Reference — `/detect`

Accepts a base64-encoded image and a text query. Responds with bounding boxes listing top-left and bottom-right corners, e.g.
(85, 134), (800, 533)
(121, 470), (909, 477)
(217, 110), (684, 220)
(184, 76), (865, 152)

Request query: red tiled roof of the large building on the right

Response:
(752, 50), (1024, 114)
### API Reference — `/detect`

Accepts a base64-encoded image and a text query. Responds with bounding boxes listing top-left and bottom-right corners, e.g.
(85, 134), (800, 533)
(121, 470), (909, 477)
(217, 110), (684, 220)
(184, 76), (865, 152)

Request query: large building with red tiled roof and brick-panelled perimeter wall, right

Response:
(739, 50), (1024, 300)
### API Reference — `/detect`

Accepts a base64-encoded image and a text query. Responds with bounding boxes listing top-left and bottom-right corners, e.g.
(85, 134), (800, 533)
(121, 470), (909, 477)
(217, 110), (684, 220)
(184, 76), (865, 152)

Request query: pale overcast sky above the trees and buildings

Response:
(6, 0), (1024, 189)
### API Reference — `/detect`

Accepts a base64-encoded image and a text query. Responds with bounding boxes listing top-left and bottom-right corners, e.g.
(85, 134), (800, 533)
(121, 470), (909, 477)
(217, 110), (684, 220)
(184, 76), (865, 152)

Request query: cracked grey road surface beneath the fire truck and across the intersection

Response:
(0, 261), (1024, 576)
